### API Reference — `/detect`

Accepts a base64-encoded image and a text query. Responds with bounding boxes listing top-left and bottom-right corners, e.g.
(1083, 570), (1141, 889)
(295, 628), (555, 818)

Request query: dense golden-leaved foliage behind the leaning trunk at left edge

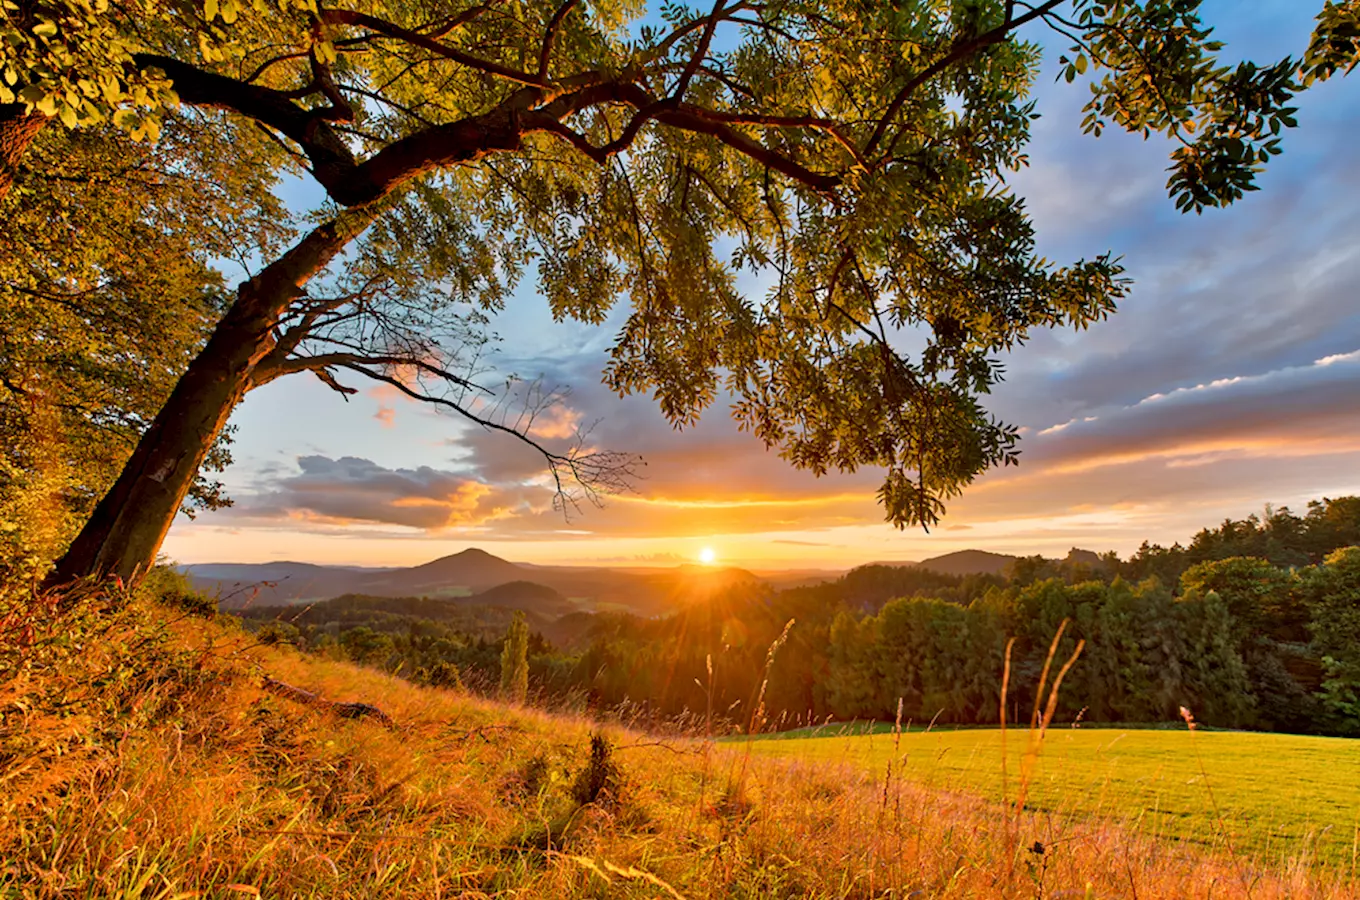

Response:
(0, 110), (286, 575)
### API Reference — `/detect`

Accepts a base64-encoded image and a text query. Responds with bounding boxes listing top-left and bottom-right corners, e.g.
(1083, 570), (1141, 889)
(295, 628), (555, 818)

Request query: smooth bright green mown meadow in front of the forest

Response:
(751, 727), (1360, 869)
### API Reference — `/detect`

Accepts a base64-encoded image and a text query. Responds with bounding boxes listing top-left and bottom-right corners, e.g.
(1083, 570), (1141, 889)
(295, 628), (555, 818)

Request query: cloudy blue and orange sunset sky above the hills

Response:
(165, 0), (1360, 570)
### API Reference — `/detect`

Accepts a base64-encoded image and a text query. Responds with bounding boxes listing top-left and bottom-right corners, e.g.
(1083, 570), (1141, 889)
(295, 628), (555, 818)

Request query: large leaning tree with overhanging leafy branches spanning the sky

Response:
(5, 0), (1338, 582)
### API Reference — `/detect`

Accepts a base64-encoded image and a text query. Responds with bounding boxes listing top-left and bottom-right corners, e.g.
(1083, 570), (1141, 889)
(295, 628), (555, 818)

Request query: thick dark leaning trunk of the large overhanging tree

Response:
(46, 208), (374, 587)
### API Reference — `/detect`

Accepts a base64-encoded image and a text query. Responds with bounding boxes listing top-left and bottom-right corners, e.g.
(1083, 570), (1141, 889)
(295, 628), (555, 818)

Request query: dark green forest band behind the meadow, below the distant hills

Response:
(236, 498), (1360, 734)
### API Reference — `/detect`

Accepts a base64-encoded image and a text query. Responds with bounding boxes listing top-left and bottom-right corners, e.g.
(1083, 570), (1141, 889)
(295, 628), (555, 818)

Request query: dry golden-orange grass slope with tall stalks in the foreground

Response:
(0, 590), (1356, 900)
